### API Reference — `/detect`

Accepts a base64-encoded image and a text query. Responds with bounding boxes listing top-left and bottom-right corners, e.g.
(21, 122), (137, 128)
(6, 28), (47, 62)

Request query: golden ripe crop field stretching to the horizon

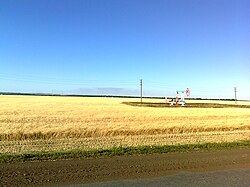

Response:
(0, 96), (250, 153)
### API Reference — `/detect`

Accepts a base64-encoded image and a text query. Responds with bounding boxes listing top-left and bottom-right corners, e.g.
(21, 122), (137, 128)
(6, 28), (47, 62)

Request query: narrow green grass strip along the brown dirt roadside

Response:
(0, 140), (250, 163)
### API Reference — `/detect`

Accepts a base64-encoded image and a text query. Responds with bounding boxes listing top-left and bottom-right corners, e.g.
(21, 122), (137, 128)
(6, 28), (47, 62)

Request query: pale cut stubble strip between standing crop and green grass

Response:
(0, 131), (249, 153)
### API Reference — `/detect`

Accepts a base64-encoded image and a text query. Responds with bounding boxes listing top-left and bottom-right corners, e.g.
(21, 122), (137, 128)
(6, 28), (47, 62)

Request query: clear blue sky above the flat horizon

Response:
(0, 0), (250, 99)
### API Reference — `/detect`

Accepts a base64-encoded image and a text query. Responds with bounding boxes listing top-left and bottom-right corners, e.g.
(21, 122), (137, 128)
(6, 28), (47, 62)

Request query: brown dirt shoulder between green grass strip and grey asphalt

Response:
(0, 147), (250, 187)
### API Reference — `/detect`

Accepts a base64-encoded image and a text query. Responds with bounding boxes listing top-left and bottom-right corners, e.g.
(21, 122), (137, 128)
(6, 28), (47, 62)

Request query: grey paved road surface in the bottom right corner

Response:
(82, 169), (250, 187)
